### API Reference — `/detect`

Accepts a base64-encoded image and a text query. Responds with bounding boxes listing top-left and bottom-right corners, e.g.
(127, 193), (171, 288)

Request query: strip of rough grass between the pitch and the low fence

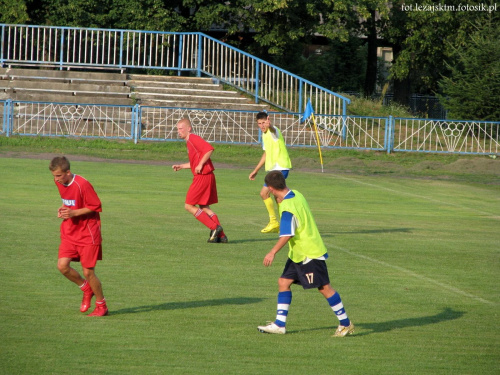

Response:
(0, 137), (500, 184)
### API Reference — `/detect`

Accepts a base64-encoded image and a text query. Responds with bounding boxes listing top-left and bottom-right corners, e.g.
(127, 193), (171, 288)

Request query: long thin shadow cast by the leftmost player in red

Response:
(109, 297), (264, 315)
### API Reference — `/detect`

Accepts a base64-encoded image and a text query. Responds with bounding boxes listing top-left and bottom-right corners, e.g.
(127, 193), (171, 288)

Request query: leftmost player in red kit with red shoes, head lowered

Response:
(49, 156), (108, 316)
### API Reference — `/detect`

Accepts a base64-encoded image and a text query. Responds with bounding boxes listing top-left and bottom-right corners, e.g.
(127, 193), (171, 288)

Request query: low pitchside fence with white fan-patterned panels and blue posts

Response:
(0, 100), (500, 155)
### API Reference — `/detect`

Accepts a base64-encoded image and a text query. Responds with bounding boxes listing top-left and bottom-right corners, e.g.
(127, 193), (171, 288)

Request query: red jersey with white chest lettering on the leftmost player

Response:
(56, 174), (102, 246)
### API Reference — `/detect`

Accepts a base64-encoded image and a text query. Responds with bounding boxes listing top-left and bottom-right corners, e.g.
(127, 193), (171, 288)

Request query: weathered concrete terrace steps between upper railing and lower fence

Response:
(0, 68), (268, 111)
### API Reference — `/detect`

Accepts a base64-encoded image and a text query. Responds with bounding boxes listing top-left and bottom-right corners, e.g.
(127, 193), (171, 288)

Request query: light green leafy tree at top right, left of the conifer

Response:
(381, 0), (494, 105)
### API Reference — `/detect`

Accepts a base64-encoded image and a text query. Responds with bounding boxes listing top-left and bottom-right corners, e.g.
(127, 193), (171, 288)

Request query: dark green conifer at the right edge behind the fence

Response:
(439, 17), (500, 121)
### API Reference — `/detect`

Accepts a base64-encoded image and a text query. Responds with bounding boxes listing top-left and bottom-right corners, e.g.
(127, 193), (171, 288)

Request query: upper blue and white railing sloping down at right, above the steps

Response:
(0, 24), (350, 116)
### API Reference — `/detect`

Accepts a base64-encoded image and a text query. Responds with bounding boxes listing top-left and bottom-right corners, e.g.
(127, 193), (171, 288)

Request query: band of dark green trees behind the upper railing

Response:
(9, 0), (498, 119)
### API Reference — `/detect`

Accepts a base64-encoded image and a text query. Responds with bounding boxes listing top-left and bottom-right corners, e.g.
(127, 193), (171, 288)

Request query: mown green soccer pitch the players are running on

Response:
(0, 153), (500, 375)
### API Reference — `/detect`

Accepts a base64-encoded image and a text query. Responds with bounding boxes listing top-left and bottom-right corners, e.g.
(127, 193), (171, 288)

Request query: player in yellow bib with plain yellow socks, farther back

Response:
(248, 112), (292, 233)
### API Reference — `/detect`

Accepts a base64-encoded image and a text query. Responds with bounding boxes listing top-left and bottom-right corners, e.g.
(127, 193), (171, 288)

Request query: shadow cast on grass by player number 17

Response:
(287, 308), (465, 337)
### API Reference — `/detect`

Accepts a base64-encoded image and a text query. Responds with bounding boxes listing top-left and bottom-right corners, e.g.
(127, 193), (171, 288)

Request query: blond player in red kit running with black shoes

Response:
(172, 118), (228, 243)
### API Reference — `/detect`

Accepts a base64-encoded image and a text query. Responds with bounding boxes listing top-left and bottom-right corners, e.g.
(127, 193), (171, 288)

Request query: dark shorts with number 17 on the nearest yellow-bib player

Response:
(281, 258), (330, 289)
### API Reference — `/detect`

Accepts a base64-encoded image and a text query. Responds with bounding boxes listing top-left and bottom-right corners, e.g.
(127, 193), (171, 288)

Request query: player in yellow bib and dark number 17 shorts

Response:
(257, 171), (354, 337)
